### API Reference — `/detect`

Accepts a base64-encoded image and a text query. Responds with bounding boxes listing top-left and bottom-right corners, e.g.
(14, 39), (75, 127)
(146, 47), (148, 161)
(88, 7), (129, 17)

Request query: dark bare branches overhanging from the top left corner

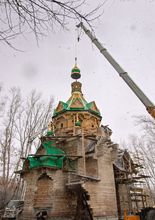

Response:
(0, 0), (103, 46)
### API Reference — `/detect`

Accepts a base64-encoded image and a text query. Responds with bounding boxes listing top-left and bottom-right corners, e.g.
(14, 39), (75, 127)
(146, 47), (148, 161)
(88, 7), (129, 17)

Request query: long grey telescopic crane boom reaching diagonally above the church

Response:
(77, 22), (155, 119)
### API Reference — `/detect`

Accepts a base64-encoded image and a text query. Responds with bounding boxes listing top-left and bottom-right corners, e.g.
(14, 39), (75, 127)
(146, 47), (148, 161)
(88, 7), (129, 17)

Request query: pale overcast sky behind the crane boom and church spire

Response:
(0, 0), (155, 142)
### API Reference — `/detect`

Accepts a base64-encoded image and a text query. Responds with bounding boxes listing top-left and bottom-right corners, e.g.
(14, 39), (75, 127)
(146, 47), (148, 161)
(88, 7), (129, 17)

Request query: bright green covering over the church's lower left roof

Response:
(28, 141), (66, 169)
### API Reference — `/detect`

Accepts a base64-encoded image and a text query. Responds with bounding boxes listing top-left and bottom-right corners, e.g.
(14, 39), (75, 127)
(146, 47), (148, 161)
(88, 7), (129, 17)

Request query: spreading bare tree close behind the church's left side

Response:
(15, 90), (53, 169)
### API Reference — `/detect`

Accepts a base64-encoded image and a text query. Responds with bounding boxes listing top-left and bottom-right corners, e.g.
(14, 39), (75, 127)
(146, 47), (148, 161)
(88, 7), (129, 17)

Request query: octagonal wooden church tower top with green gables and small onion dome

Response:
(52, 64), (102, 137)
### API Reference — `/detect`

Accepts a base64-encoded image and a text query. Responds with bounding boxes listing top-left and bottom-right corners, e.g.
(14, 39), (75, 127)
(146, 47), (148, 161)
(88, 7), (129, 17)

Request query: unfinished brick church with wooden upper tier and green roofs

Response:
(21, 66), (118, 220)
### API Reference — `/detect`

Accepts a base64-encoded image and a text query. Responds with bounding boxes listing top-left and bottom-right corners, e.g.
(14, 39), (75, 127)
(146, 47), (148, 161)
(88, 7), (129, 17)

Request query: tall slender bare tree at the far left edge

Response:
(0, 89), (20, 208)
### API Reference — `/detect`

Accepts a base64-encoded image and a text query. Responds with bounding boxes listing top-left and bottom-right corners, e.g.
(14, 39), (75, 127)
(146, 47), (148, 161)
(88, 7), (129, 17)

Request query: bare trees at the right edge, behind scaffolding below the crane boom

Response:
(122, 113), (155, 205)
